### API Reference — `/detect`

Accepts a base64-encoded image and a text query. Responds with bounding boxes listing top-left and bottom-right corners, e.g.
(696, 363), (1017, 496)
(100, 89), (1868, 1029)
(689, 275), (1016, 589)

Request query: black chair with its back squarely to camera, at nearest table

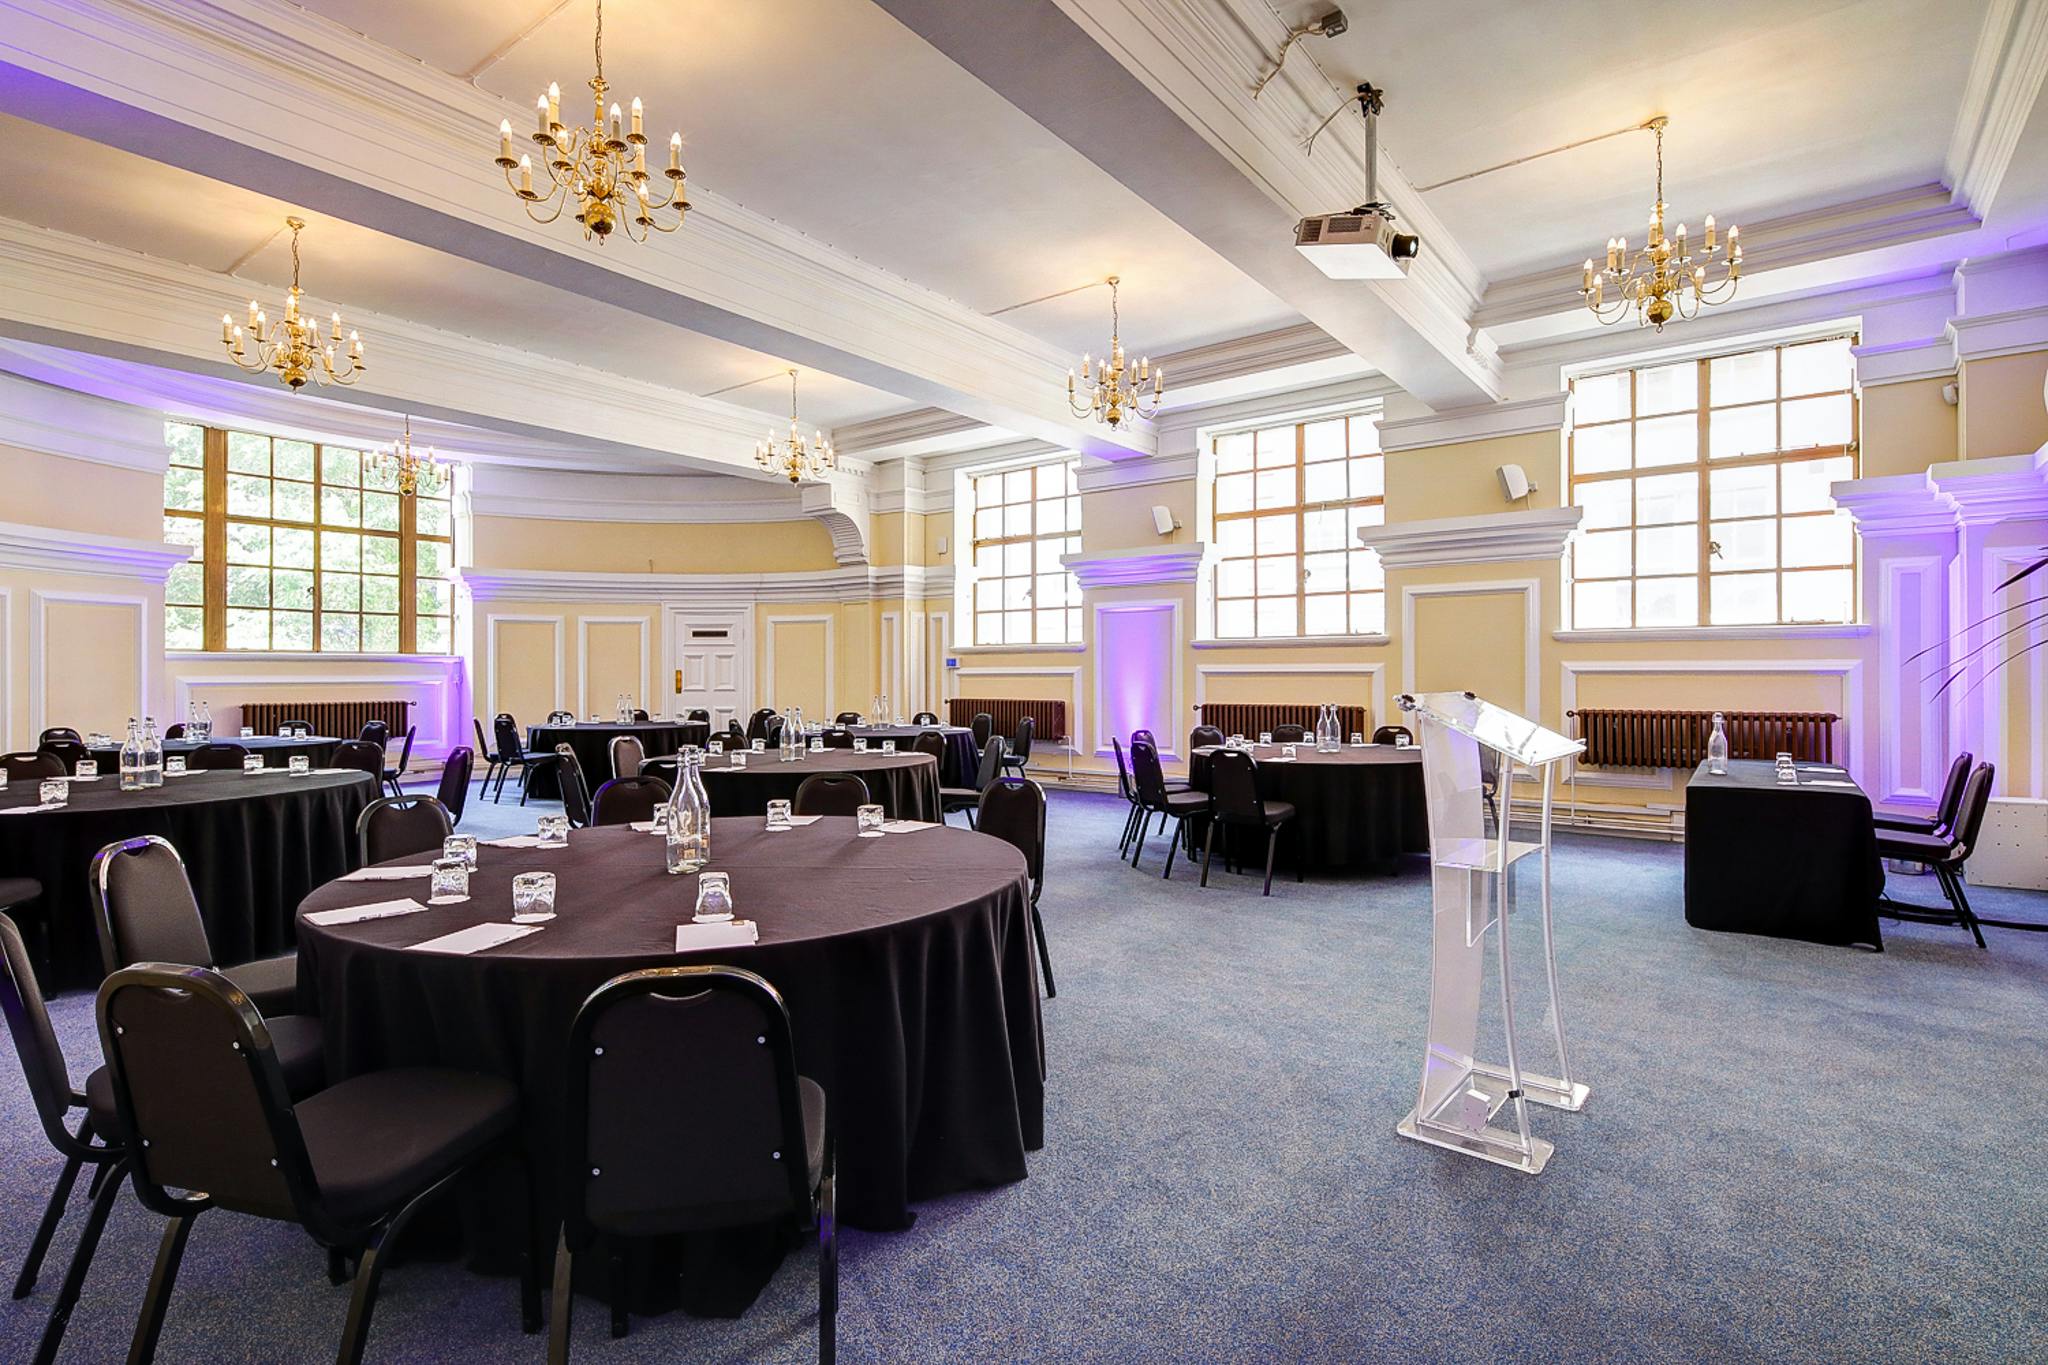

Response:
(547, 966), (840, 1365)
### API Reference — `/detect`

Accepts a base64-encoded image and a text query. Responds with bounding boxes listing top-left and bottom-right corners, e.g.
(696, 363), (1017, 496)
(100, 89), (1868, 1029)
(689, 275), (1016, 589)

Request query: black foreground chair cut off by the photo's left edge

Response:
(0, 915), (127, 1365)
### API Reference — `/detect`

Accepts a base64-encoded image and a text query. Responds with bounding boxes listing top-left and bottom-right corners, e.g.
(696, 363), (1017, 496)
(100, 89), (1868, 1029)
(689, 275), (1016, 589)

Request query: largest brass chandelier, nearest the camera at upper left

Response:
(498, 0), (690, 246)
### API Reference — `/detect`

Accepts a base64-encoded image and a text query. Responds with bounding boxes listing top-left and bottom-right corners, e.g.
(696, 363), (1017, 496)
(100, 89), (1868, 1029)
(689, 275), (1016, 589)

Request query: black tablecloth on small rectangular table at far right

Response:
(1686, 759), (1884, 943)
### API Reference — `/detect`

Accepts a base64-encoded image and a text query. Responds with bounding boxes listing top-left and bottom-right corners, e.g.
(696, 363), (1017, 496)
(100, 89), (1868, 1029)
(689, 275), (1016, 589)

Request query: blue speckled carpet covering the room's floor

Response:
(0, 777), (2048, 1363)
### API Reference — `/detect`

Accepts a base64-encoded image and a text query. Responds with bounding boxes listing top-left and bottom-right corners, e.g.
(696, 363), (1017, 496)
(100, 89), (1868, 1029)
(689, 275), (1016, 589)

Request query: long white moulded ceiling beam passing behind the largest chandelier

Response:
(0, 0), (1155, 458)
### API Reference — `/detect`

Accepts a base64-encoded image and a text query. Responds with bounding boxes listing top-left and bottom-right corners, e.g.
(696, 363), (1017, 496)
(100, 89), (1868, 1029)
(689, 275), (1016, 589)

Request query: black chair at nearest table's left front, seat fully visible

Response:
(96, 962), (541, 1365)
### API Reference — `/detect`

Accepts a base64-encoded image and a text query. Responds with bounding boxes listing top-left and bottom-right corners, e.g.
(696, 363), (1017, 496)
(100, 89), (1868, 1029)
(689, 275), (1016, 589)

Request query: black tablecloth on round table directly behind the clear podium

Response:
(1188, 743), (1430, 870)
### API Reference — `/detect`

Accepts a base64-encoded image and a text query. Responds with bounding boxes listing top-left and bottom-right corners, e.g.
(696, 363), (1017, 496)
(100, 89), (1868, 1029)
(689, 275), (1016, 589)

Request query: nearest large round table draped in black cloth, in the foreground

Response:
(299, 817), (1044, 1246)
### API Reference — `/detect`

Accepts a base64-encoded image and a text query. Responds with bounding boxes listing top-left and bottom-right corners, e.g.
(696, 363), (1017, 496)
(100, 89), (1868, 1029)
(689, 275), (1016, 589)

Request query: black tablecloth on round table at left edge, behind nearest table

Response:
(0, 769), (377, 986)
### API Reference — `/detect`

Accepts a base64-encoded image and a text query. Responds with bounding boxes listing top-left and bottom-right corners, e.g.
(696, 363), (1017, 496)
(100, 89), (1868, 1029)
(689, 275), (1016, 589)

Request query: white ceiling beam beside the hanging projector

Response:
(877, 0), (1499, 407)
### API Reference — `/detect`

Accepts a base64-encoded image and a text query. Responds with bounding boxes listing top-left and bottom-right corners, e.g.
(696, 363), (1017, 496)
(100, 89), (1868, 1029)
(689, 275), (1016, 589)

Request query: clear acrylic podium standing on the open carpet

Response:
(1397, 692), (1587, 1175)
